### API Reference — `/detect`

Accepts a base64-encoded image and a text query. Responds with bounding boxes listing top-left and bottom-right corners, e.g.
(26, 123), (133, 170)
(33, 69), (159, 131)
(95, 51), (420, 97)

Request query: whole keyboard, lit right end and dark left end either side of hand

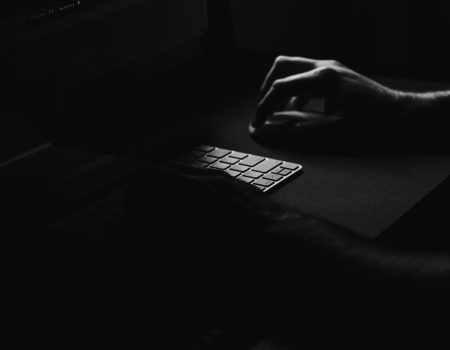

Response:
(53, 146), (303, 237)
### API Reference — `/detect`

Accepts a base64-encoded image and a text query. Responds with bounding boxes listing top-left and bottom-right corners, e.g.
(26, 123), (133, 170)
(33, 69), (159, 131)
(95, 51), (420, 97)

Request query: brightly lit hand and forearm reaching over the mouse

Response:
(253, 56), (450, 131)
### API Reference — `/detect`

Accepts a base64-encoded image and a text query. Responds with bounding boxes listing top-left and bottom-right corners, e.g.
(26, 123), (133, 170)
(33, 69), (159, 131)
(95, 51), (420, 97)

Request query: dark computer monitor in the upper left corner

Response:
(0, 0), (207, 82)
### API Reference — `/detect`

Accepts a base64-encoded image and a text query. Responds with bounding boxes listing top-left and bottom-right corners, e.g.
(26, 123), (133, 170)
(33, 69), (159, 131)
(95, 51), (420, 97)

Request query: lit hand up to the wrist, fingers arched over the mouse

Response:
(253, 56), (410, 128)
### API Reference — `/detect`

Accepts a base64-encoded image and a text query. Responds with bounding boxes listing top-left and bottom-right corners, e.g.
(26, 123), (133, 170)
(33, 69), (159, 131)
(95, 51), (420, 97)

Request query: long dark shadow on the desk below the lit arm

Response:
(254, 119), (450, 156)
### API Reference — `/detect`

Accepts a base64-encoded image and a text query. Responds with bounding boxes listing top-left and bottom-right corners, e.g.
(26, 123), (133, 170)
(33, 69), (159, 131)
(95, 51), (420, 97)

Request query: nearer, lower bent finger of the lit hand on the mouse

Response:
(253, 67), (334, 127)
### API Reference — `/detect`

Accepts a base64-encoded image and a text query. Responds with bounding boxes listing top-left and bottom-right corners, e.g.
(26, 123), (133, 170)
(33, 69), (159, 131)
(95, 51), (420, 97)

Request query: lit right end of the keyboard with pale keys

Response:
(173, 146), (303, 192)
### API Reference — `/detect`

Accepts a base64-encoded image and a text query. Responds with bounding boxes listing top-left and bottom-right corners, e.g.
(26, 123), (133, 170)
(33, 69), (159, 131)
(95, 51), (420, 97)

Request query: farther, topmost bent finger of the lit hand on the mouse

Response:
(261, 56), (317, 95)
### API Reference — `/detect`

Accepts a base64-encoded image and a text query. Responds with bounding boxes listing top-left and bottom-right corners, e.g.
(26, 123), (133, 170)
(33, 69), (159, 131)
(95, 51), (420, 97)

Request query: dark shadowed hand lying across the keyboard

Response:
(125, 166), (293, 262)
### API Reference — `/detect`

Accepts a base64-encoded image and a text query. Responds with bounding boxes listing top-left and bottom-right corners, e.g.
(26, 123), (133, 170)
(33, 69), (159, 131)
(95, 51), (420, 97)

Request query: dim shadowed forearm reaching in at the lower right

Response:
(264, 218), (450, 292)
